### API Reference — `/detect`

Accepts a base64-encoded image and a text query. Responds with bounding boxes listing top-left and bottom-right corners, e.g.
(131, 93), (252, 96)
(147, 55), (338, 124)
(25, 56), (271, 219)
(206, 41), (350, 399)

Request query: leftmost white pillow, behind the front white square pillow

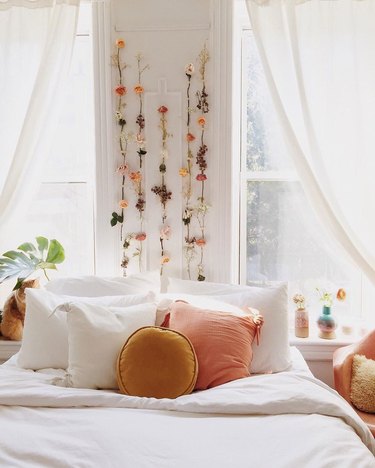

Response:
(17, 288), (154, 370)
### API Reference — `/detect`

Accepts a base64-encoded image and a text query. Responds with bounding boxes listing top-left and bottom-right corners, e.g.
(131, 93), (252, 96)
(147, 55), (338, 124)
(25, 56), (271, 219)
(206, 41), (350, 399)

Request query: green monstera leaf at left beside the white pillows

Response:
(0, 236), (65, 289)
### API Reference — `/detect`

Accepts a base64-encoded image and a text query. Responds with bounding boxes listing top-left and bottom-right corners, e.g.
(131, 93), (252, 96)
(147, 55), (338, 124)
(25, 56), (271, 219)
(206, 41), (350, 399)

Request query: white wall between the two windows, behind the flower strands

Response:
(103, 0), (238, 281)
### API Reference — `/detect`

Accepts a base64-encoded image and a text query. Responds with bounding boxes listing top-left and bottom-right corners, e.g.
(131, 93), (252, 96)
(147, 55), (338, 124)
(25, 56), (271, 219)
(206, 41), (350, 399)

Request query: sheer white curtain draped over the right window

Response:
(247, 0), (375, 284)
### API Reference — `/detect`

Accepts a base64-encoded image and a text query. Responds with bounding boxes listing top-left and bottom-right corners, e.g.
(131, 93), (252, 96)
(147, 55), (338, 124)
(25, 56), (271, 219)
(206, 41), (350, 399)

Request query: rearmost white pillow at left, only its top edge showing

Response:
(45, 272), (160, 297)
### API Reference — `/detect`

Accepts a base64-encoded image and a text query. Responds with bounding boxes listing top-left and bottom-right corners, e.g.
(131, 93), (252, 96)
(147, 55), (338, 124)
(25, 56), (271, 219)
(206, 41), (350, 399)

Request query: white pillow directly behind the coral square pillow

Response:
(164, 278), (291, 374)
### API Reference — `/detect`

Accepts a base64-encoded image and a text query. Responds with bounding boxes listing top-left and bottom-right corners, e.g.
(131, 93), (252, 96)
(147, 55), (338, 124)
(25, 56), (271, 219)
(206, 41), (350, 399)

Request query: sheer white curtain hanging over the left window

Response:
(0, 0), (79, 253)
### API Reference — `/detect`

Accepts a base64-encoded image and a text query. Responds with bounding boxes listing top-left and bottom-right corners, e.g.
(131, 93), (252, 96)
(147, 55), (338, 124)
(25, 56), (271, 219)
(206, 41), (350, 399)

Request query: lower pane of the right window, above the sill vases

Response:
(247, 181), (345, 281)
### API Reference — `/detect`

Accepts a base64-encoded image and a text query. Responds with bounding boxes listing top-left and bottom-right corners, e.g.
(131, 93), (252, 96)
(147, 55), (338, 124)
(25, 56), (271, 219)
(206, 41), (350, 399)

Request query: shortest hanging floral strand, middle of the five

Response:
(151, 106), (172, 275)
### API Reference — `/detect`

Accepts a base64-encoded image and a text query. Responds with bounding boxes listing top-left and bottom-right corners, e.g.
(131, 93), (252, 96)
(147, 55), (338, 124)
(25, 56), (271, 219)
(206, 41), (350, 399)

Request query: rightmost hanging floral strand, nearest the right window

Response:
(195, 44), (210, 281)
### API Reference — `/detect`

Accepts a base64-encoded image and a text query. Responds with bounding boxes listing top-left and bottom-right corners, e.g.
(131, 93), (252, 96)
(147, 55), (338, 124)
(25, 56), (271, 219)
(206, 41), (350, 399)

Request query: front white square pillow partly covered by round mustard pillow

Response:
(58, 303), (156, 389)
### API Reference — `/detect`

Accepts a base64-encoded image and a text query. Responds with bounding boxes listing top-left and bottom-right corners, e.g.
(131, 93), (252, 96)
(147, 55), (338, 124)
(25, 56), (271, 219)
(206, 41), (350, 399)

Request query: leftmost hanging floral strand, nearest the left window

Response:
(111, 39), (131, 276)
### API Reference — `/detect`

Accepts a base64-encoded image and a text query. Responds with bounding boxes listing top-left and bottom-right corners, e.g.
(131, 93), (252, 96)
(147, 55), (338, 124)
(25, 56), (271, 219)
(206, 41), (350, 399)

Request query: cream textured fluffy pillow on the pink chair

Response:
(350, 354), (375, 413)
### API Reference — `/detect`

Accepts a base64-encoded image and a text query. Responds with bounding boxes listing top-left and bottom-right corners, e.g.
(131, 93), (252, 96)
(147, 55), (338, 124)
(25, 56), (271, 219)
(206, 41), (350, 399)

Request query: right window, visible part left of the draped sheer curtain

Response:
(235, 2), (364, 326)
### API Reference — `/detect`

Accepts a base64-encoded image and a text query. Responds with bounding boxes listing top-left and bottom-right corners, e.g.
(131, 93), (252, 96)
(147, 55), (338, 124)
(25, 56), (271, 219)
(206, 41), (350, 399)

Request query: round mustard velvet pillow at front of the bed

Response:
(117, 327), (198, 398)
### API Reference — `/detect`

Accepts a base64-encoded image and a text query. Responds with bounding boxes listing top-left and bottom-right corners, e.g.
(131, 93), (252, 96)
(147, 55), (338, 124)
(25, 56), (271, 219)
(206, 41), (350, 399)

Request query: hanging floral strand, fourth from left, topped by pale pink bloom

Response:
(179, 63), (195, 279)
